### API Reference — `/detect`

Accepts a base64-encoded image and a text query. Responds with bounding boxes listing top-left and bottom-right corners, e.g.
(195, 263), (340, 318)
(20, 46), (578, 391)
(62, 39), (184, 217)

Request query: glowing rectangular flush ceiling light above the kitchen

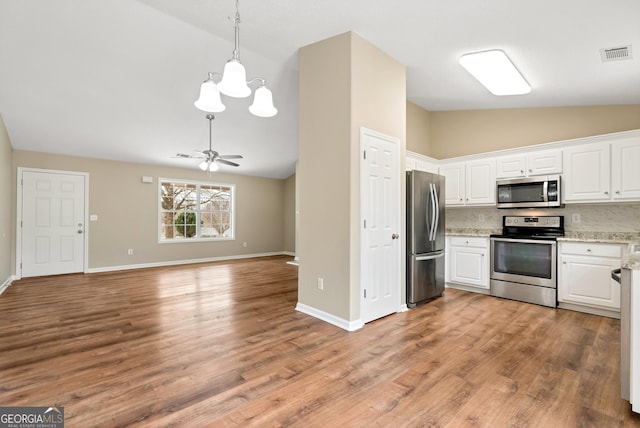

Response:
(460, 49), (531, 95)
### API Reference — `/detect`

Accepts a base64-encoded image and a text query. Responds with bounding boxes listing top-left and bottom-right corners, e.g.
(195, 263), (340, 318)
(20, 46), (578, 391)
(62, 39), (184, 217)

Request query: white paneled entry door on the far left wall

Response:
(20, 171), (85, 277)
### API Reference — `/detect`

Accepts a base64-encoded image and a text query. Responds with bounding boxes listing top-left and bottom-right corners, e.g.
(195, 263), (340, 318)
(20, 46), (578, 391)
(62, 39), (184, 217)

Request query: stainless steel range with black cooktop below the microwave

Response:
(491, 216), (564, 308)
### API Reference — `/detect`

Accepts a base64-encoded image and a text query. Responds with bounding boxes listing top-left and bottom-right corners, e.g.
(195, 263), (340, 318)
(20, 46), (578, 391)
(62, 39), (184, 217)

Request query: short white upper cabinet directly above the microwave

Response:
(496, 149), (562, 178)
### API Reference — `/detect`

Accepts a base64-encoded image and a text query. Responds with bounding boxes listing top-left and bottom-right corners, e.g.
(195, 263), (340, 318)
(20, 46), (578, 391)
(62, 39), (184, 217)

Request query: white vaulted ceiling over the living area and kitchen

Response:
(0, 0), (640, 178)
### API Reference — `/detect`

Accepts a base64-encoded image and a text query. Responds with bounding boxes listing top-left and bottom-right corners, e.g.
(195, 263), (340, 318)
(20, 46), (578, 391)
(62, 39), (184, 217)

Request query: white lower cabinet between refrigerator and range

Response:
(445, 236), (489, 292)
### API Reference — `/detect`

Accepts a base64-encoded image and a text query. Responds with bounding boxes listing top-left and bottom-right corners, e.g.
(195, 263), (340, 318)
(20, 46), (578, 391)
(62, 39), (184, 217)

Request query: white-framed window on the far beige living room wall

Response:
(159, 178), (234, 242)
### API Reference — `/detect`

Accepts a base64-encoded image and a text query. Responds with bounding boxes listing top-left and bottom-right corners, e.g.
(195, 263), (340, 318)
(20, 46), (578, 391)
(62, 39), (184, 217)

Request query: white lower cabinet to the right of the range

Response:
(558, 242), (622, 315)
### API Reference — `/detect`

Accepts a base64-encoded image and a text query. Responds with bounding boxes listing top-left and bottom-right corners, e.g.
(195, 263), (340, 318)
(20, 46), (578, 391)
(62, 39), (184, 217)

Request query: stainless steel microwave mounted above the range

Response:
(496, 175), (562, 208)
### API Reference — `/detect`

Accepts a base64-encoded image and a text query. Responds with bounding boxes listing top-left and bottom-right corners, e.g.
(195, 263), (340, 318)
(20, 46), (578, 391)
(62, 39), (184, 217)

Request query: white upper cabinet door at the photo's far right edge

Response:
(611, 137), (640, 200)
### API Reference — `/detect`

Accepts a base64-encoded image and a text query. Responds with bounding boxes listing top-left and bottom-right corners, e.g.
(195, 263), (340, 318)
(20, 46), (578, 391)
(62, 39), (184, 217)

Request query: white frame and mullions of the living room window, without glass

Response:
(156, 177), (237, 244)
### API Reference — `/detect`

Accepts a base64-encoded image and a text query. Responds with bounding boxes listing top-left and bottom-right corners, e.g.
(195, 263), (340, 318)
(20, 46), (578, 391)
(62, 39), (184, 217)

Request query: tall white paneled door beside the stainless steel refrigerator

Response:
(360, 129), (403, 323)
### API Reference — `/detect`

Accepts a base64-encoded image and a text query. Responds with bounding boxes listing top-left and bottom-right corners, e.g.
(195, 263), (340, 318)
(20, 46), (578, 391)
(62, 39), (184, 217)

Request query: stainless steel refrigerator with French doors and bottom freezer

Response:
(406, 171), (445, 308)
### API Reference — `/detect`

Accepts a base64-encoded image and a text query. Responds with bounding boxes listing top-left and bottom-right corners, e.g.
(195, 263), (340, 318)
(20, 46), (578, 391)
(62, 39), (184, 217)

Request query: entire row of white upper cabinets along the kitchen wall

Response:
(406, 129), (640, 207)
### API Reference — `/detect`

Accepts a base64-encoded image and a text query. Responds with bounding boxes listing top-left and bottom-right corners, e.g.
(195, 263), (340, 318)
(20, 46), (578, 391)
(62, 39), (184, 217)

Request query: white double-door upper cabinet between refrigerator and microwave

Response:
(440, 159), (496, 206)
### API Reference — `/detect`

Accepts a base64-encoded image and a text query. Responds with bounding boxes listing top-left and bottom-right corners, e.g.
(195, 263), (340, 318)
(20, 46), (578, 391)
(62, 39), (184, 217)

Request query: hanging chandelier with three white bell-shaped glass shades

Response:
(194, 0), (278, 117)
